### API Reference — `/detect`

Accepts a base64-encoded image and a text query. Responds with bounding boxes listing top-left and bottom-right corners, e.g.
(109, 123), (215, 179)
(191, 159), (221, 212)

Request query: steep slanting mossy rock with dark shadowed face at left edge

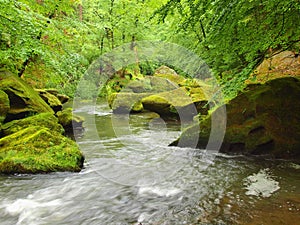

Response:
(0, 71), (54, 121)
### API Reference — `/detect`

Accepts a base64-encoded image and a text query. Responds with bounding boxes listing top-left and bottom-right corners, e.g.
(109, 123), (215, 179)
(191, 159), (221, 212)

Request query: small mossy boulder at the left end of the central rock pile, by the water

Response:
(107, 92), (151, 114)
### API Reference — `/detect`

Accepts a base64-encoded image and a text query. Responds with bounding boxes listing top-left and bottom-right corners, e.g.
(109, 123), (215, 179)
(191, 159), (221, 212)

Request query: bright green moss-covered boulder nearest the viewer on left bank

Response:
(0, 126), (84, 174)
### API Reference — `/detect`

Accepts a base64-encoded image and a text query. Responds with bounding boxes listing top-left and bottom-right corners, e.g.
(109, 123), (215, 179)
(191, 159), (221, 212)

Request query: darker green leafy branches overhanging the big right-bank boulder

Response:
(156, 0), (300, 96)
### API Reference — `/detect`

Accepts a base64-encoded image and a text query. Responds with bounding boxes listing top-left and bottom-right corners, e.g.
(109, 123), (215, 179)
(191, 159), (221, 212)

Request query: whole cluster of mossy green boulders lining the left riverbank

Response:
(0, 71), (84, 174)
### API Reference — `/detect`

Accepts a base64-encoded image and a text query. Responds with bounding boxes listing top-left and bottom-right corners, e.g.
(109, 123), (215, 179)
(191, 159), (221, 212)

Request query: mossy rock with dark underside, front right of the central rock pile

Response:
(142, 88), (207, 120)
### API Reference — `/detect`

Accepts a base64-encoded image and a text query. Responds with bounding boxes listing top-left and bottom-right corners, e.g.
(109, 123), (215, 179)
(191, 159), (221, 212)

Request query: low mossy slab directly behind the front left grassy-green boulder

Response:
(2, 113), (64, 136)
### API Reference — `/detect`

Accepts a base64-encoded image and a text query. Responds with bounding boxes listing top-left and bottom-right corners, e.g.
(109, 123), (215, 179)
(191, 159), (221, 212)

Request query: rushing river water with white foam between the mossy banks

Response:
(0, 103), (300, 225)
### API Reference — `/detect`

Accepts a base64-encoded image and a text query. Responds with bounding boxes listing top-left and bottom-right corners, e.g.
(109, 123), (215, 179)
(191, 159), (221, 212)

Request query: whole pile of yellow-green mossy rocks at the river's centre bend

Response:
(107, 66), (211, 117)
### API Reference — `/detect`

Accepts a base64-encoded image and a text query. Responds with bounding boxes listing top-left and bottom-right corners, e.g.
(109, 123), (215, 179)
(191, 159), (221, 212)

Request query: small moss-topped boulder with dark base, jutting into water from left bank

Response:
(56, 108), (84, 136)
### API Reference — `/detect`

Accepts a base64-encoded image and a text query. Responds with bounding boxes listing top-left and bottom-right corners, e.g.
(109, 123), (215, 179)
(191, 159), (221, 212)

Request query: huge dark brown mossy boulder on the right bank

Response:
(171, 77), (300, 159)
